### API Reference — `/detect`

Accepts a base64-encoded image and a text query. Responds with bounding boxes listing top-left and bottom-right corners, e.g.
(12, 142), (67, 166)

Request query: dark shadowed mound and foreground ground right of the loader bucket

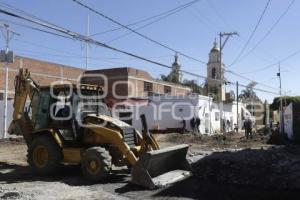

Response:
(153, 146), (300, 200)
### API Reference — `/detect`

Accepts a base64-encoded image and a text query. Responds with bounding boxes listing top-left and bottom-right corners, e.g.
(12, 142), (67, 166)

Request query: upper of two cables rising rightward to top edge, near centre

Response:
(90, 1), (202, 36)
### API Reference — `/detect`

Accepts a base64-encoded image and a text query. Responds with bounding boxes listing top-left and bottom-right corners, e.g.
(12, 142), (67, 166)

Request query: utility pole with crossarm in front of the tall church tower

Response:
(219, 32), (238, 132)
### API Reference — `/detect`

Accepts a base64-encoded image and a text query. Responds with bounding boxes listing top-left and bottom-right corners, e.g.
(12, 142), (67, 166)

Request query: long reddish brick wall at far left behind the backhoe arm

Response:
(0, 56), (84, 100)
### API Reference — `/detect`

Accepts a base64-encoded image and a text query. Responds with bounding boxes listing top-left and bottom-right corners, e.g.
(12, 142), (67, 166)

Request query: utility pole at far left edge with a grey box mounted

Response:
(0, 24), (20, 138)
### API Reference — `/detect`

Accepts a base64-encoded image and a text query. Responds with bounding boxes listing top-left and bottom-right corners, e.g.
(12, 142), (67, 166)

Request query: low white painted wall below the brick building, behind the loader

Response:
(116, 95), (250, 134)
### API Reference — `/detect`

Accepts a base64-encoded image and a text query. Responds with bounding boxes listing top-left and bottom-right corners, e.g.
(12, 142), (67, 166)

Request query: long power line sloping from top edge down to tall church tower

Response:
(72, 0), (206, 64)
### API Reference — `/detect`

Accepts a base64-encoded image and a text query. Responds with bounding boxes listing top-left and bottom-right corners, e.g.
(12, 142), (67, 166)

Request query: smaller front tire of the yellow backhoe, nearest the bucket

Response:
(81, 147), (112, 181)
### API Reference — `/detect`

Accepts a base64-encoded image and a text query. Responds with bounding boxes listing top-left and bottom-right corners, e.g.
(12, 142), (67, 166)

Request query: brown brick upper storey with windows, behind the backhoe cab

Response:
(82, 67), (191, 99)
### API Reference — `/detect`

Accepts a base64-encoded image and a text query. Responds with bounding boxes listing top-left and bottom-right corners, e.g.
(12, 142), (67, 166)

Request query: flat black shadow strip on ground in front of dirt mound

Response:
(153, 177), (300, 200)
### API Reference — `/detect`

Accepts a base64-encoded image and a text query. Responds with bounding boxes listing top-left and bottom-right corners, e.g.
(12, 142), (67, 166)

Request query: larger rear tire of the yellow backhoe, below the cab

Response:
(27, 135), (63, 175)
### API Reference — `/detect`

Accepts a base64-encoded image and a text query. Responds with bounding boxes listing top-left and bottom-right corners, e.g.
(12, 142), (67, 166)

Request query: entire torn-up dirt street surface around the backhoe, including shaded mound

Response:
(0, 132), (300, 199)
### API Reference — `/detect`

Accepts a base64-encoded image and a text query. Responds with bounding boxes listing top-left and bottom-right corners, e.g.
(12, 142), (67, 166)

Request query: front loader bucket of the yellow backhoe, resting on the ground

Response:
(131, 144), (191, 189)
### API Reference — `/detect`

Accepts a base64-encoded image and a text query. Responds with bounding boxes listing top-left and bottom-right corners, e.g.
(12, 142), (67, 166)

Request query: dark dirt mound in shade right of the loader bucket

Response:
(193, 146), (300, 189)
